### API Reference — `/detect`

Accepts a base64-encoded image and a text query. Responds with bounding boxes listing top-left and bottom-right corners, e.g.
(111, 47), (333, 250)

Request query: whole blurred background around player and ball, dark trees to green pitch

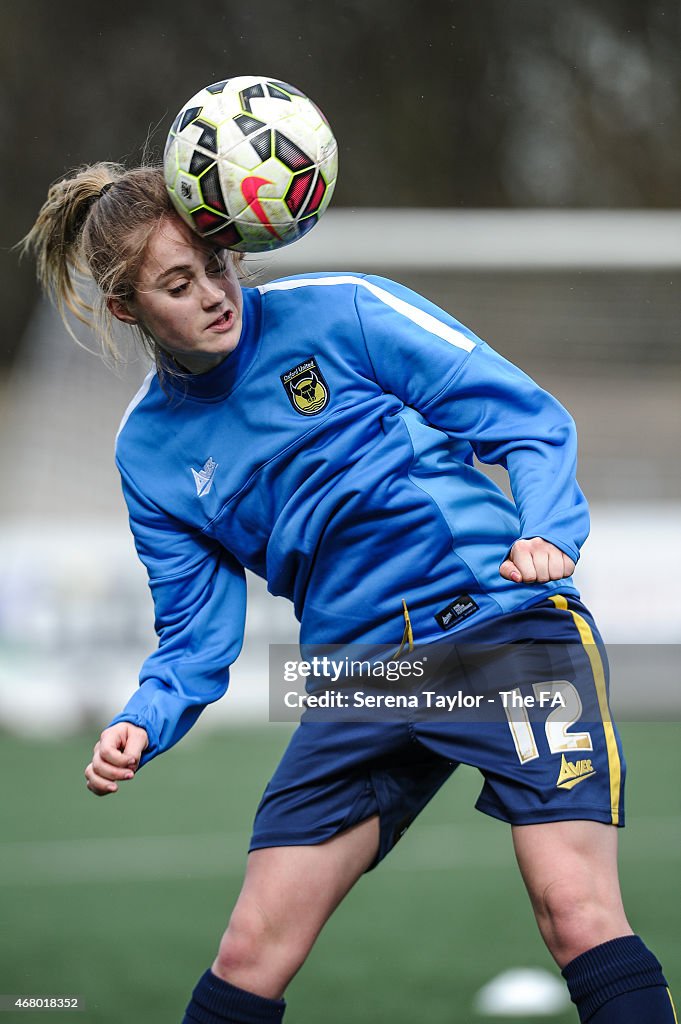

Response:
(0, 0), (681, 1024)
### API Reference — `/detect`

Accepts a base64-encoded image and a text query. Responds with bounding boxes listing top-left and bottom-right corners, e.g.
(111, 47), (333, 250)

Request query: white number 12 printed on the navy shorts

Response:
(502, 679), (593, 764)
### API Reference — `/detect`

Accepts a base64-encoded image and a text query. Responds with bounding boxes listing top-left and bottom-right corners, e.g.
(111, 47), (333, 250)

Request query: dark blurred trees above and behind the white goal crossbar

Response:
(0, 0), (681, 360)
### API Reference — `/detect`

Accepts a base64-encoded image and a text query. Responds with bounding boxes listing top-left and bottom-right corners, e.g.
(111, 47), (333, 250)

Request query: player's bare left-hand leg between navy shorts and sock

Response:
(211, 816), (379, 999)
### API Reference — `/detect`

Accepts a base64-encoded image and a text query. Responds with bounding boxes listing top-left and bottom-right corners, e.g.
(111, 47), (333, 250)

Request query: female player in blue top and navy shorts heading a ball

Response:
(26, 164), (675, 1024)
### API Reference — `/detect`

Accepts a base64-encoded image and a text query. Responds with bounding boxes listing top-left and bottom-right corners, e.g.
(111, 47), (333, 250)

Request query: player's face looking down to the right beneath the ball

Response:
(129, 216), (243, 373)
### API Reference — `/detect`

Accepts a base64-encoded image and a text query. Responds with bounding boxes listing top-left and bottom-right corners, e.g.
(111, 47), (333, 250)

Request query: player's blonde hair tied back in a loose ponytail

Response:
(19, 163), (239, 372)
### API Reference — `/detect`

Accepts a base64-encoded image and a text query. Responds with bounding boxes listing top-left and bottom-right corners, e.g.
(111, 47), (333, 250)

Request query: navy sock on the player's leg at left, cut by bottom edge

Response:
(182, 970), (286, 1024)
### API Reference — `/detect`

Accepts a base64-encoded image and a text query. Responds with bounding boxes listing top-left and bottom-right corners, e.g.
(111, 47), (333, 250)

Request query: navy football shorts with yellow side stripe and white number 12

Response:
(250, 595), (625, 866)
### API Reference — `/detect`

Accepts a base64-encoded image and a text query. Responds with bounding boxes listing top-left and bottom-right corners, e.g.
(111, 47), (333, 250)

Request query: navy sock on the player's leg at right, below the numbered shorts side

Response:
(562, 935), (676, 1024)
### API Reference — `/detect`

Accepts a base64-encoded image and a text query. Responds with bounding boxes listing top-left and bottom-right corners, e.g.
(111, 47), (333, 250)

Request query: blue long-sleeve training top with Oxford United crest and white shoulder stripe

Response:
(111, 273), (589, 763)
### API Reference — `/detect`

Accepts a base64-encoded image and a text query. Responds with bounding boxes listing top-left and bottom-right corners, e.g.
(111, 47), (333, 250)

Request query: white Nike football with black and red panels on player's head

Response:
(164, 75), (338, 252)
